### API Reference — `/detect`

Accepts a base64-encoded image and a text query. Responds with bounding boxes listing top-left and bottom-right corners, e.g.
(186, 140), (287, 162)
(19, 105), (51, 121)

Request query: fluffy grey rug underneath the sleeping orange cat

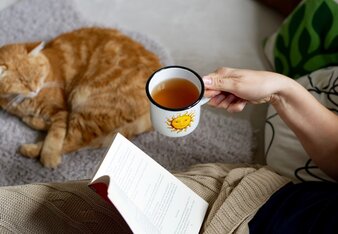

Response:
(0, 0), (255, 186)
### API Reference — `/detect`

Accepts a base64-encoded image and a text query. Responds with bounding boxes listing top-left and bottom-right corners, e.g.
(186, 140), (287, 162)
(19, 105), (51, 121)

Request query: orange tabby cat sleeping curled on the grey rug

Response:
(0, 28), (161, 168)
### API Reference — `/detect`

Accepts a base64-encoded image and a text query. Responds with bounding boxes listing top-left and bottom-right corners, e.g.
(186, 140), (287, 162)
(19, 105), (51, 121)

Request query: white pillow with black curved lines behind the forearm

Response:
(265, 67), (338, 182)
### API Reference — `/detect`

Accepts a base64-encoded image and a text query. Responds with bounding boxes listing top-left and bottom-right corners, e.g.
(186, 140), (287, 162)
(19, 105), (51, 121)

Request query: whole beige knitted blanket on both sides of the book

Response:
(0, 164), (289, 234)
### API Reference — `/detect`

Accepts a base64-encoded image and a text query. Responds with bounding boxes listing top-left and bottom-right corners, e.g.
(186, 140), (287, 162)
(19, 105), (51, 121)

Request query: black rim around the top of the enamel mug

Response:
(146, 65), (204, 111)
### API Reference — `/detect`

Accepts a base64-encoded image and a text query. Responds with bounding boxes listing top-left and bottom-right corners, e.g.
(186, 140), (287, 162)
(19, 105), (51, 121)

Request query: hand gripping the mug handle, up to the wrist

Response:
(203, 67), (286, 112)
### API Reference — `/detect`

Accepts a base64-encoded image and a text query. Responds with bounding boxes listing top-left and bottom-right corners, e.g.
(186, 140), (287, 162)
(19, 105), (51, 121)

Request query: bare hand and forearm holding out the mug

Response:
(203, 67), (338, 180)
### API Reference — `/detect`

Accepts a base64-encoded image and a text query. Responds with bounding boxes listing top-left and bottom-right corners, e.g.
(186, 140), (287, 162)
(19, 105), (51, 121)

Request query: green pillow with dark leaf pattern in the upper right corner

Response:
(264, 0), (338, 79)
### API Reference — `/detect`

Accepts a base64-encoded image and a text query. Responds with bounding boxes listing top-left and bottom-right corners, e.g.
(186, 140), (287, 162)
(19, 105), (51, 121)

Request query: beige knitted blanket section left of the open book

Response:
(0, 181), (130, 234)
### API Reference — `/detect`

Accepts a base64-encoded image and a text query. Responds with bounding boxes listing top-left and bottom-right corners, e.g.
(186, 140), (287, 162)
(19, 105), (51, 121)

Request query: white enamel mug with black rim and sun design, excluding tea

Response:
(146, 66), (209, 137)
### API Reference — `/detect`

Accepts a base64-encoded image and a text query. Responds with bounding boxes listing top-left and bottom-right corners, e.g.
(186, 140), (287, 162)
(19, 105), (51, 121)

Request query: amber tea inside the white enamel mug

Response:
(151, 78), (200, 109)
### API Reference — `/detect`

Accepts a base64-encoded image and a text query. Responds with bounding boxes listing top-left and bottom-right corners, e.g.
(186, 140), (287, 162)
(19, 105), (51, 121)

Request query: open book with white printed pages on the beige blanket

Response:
(89, 133), (208, 234)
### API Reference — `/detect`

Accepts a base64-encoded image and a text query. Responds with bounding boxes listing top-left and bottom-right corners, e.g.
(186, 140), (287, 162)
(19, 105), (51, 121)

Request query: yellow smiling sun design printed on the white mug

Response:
(166, 112), (195, 133)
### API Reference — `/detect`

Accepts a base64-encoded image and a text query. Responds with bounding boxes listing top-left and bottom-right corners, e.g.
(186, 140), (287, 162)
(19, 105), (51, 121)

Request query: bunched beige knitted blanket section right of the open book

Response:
(176, 164), (290, 234)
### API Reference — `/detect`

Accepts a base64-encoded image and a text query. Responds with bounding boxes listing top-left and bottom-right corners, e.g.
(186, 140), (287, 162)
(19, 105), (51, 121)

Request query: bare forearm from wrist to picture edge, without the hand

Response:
(272, 78), (338, 180)
